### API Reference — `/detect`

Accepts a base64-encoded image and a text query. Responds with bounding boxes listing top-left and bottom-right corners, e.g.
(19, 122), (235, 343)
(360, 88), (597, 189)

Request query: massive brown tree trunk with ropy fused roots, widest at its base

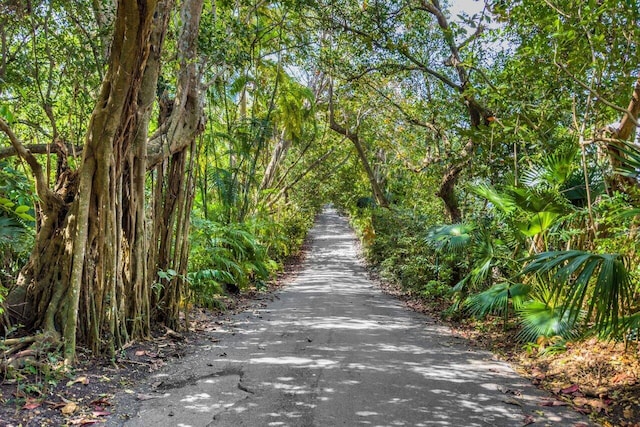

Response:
(26, 0), (161, 363)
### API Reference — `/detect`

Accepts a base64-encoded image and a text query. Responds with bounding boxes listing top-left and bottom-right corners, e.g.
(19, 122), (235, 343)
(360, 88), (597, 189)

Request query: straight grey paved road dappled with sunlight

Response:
(116, 209), (590, 427)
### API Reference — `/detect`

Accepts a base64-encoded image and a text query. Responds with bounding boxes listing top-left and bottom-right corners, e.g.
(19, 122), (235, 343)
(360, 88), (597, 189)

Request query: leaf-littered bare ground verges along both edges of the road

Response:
(0, 241), (640, 427)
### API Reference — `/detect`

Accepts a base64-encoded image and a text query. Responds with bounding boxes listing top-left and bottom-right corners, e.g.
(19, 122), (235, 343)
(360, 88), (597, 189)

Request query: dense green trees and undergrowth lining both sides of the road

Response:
(0, 0), (640, 380)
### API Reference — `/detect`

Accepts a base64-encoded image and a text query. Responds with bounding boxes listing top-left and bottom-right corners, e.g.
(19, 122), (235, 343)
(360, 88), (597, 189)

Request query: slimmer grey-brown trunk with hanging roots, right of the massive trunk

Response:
(148, 0), (204, 329)
